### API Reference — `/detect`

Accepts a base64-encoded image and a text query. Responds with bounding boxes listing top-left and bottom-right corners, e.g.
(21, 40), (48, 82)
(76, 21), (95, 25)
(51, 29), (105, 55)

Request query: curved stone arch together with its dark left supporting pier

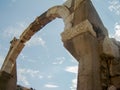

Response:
(0, 5), (71, 90)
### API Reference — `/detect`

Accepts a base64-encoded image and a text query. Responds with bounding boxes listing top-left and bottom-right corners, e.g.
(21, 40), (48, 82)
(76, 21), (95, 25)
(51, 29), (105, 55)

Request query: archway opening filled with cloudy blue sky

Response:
(17, 19), (77, 90)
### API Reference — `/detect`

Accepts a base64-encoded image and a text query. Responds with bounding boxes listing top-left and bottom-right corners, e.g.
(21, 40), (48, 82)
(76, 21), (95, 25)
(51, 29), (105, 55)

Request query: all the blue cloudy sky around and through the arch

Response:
(0, 0), (120, 90)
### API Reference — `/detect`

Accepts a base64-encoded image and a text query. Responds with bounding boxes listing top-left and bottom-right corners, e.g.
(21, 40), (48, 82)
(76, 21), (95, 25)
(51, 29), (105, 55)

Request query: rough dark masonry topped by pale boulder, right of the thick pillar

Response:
(101, 36), (120, 90)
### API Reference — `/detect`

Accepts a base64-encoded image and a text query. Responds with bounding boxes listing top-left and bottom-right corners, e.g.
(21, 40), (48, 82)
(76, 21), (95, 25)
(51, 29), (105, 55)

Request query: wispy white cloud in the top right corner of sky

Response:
(108, 0), (120, 15)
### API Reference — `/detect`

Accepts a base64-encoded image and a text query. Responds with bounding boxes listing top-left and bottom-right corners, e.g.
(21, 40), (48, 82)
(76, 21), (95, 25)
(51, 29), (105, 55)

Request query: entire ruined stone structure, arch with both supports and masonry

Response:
(0, 0), (120, 90)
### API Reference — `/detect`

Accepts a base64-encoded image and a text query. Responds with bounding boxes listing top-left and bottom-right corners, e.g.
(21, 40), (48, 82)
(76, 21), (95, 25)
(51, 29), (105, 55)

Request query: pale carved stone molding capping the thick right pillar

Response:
(61, 20), (96, 41)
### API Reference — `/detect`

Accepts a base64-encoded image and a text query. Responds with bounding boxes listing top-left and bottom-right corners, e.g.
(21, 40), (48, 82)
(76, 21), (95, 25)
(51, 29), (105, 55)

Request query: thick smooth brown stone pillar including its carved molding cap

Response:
(61, 20), (102, 90)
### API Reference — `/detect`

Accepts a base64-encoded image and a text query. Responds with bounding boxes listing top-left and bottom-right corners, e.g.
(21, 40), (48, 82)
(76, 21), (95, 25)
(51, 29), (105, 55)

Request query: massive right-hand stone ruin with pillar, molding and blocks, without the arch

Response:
(61, 0), (120, 90)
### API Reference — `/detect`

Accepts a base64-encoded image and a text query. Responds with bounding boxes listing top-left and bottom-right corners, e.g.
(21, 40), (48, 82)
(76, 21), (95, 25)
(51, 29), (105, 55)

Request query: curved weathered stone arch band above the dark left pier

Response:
(1, 5), (71, 75)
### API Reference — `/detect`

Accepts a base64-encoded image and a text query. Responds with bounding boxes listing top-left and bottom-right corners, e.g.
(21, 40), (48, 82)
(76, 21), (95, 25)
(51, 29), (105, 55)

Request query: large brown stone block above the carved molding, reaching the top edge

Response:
(73, 0), (108, 37)
